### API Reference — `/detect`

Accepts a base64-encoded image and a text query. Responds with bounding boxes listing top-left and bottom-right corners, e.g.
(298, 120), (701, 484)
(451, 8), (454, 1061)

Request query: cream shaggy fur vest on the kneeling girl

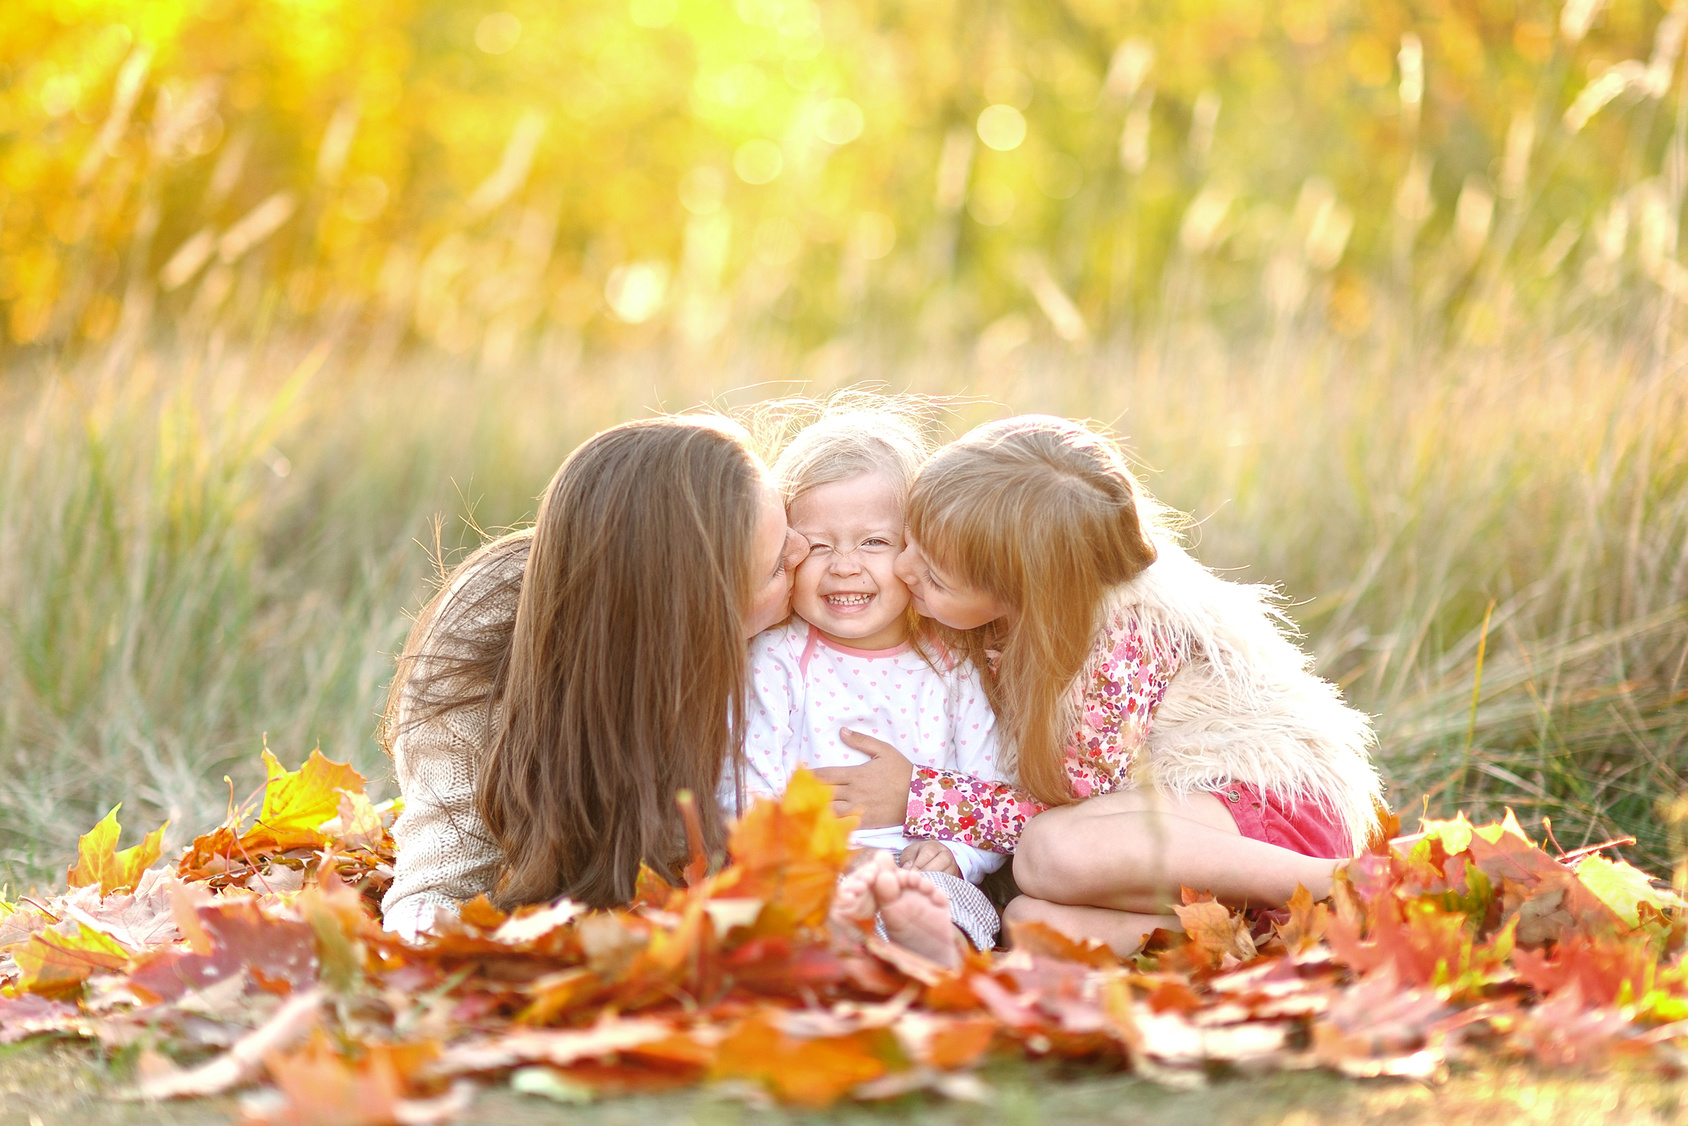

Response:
(1107, 533), (1382, 854)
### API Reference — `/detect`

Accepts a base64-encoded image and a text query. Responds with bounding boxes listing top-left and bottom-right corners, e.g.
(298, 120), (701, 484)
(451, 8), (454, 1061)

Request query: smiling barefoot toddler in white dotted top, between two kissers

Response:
(743, 410), (1004, 962)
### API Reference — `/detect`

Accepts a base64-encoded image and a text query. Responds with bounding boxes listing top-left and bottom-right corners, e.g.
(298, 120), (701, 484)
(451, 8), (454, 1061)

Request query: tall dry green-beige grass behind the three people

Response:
(0, 299), (1688, 883)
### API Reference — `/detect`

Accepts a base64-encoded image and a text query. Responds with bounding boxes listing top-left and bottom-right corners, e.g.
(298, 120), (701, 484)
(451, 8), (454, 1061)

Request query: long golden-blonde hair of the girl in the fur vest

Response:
(906, 415), (1155, 805)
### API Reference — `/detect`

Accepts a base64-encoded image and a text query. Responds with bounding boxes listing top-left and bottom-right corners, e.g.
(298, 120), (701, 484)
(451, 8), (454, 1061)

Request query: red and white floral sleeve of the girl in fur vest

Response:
(903, 618), (1180, 853)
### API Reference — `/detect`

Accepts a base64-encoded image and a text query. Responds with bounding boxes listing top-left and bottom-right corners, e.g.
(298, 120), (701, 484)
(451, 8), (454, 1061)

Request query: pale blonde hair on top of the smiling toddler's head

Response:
(773, 406), (932, 508)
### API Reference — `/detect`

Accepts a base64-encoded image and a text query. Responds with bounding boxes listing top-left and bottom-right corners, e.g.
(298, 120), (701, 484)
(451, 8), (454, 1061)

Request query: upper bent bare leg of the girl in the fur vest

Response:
(1014, 790), (1340, 915)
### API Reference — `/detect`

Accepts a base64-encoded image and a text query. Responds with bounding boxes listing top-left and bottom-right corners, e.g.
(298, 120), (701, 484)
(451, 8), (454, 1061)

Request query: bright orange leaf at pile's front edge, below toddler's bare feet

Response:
(711, 1012), (901, 1109)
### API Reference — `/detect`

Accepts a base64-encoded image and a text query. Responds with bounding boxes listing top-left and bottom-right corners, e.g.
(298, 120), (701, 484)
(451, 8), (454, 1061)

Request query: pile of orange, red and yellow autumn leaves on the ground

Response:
(0, 753), (1688, 1123)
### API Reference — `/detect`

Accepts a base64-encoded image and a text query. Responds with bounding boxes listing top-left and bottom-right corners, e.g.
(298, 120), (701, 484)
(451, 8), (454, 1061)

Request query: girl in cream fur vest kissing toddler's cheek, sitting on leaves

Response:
(819, 415), (1381, 952)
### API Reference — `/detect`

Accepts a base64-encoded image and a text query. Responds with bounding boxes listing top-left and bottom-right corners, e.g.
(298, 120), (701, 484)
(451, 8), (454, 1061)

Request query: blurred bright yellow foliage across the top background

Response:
(0, 0), (1685, 355)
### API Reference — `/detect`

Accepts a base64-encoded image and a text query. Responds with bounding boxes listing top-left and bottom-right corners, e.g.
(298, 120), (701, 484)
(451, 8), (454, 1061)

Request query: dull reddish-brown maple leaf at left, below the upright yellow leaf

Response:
(130, 898), (317, 1001)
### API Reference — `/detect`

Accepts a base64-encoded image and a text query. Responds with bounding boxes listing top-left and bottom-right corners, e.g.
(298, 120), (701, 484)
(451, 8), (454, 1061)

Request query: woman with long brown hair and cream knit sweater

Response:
(383, 415), (800, 934)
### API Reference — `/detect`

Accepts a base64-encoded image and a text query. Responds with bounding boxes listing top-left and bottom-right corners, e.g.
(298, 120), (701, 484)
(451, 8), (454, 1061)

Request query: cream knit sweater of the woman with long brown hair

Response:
(381, 550), (527, 935)
